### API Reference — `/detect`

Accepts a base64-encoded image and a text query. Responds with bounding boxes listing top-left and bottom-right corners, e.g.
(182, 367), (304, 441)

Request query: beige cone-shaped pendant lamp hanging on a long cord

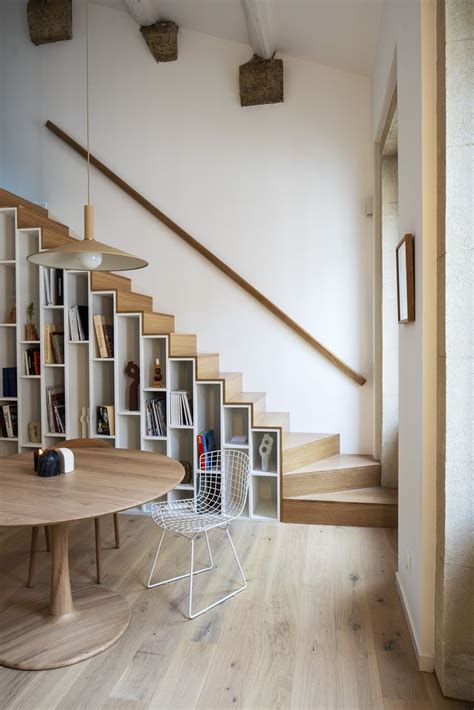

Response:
(27, 0), (148, 271)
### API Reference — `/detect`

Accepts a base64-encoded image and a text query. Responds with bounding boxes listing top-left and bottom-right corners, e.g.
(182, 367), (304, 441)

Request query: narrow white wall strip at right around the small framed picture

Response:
(372, 0), (436, 670)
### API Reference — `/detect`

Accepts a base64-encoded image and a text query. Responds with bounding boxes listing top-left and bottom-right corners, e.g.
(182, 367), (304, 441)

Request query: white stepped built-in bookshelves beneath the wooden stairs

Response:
(0, 208), (281, 520)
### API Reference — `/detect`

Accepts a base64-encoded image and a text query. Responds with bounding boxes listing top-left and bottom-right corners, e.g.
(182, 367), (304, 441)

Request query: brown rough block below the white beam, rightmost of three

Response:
(239, 54), (283, 106)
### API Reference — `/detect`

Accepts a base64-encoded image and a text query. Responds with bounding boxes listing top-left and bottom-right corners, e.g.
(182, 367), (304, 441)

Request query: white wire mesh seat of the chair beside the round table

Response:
(151, 498), (235, 535)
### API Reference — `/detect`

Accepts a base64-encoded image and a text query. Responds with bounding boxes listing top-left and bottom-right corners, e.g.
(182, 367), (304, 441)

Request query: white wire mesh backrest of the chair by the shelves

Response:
(198, 449), (250, 517)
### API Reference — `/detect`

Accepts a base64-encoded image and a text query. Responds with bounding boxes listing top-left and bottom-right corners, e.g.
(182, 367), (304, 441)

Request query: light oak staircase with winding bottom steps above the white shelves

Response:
(0, 189), (397, 527)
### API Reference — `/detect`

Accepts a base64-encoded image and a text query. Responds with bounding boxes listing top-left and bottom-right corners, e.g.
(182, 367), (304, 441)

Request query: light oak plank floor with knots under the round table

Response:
(0, 515), (463, 710)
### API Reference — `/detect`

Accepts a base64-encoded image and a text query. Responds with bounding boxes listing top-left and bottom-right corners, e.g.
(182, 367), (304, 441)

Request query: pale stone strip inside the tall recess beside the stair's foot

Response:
(382, 155), (400, 488)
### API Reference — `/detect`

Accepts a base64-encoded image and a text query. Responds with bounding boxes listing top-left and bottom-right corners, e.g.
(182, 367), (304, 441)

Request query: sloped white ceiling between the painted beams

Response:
(95, 0), (384, 75)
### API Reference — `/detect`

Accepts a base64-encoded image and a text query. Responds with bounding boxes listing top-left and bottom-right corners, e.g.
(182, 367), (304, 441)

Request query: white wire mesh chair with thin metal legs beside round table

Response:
(147, 449), (250, 619)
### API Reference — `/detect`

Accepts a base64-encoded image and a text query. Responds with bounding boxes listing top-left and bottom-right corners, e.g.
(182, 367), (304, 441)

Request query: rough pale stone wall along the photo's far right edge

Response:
(435, 0), (474, 701)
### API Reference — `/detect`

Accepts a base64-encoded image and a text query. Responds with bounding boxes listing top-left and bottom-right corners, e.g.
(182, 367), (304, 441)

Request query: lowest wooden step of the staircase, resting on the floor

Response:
(281, 487), (398, 528)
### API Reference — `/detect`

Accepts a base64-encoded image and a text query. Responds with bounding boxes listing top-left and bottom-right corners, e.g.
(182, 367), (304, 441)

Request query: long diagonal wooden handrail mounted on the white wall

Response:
(46, 121), (367, 385)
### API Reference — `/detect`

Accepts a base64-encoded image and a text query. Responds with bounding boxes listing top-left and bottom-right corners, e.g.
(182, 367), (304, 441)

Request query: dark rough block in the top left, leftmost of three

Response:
(26, 0), (72, 45)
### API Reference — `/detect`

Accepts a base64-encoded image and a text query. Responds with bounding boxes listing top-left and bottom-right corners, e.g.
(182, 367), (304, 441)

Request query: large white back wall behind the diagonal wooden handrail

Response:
(3, 0), (372, 452)
